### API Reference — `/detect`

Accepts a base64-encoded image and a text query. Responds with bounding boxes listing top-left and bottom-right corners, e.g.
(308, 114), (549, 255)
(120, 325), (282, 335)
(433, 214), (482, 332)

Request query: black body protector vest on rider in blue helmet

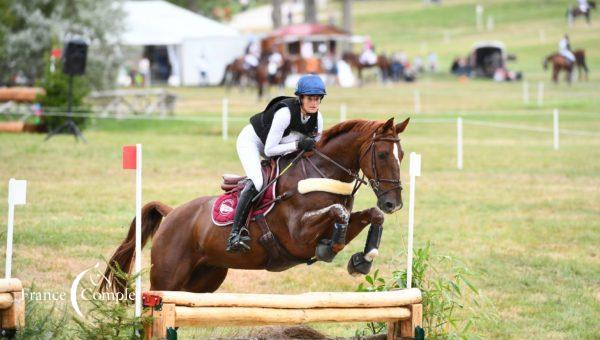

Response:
(250, 96), (318, 144)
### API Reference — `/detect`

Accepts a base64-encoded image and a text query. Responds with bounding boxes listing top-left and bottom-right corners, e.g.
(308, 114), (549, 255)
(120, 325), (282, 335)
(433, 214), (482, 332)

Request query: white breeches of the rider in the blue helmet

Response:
(236, 124), (265, 191)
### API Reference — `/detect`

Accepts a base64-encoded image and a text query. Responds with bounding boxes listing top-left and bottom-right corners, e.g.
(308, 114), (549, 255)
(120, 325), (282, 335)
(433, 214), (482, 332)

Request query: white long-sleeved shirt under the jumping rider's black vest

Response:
(264, 107), (323, 157)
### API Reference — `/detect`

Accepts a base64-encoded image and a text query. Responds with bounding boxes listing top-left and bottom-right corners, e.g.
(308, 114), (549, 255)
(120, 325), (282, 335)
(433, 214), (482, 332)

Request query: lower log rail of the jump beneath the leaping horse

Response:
(171, 306), (411, 327)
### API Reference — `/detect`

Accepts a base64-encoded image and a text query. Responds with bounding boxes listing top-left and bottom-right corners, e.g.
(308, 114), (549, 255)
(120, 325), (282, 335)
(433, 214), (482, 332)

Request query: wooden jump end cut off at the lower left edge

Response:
(0, 279), (25, 337)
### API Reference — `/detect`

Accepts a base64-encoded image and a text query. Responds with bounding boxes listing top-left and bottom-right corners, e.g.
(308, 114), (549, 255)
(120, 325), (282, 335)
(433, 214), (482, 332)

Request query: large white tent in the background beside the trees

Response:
(121, 0), (247, 85)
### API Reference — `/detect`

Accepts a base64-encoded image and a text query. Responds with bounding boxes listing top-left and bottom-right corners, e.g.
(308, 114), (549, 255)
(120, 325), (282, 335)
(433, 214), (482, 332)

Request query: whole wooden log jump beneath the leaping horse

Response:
(143, 288), (423, 339)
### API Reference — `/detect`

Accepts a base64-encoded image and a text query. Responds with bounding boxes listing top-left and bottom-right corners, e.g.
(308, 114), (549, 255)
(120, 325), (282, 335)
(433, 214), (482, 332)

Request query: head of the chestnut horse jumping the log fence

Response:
(359, 118), (409, 214)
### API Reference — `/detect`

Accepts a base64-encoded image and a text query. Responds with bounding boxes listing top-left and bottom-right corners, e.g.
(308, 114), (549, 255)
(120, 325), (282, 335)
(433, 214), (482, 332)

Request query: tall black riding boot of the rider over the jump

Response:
(225, 180), (258, 253)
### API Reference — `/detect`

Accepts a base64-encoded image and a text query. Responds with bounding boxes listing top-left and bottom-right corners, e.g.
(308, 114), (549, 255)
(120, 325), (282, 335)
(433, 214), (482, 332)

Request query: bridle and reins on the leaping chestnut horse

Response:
(313, 133), (402, 198)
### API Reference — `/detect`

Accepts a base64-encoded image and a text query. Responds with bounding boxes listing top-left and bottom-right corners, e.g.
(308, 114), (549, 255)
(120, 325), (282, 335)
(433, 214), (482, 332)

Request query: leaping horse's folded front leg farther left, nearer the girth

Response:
(295, 203), (350, 262)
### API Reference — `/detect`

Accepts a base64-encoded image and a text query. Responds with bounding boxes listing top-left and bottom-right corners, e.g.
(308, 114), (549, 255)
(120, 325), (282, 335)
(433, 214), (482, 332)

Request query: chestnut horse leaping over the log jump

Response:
(100, 118), (408, 292)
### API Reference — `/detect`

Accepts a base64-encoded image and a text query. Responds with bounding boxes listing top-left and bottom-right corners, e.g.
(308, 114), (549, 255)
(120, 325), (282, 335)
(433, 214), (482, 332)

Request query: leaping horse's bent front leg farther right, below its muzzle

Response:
(346, 207), (384, 276)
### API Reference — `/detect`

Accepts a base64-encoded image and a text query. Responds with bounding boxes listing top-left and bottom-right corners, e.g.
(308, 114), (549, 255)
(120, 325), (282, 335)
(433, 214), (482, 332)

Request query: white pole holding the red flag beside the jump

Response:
(135, 144), (142, 317)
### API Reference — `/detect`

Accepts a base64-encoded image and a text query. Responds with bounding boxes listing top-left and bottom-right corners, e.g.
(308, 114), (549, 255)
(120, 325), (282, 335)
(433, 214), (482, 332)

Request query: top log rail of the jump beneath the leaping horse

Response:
(150, 288), (421, 309)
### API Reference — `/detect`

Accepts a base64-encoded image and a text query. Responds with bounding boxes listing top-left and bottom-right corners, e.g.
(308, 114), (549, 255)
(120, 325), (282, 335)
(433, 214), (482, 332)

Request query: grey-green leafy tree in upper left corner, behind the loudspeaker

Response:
(0, 0), (124, 88)
